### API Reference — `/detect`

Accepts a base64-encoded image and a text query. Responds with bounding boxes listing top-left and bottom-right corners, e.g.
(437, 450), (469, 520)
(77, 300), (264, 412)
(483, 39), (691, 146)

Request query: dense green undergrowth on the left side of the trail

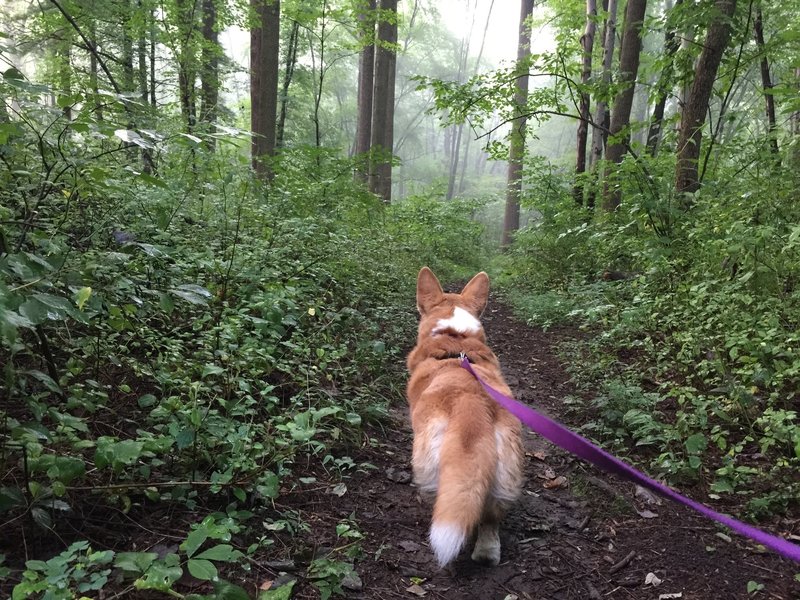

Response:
(0, 54), (486, 597)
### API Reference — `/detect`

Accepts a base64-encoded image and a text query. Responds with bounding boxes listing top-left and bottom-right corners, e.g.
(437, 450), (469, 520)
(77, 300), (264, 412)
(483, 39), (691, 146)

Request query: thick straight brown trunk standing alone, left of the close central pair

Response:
(250, 0), (281, 181)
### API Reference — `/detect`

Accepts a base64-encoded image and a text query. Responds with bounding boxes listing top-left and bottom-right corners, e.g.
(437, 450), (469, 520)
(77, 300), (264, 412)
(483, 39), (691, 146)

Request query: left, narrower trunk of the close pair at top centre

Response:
(353, 0), (375, 183)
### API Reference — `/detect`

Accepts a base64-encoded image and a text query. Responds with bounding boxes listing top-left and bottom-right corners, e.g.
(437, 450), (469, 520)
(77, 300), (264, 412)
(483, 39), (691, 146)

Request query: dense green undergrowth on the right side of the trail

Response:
(503, 146), (800, 514)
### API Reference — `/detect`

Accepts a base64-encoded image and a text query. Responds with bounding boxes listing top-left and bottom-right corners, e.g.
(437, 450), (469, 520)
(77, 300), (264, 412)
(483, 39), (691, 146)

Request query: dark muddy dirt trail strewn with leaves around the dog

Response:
(282, 298), (800, 600)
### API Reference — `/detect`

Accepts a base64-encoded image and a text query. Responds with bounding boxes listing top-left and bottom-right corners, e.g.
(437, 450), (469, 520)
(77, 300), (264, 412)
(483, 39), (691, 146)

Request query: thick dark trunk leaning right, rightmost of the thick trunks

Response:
(675, 0), (736, 196)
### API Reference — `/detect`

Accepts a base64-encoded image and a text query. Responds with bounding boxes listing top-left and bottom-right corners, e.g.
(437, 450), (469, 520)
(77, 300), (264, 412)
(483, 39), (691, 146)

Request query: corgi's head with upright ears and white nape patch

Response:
(417, 267), (489, 337)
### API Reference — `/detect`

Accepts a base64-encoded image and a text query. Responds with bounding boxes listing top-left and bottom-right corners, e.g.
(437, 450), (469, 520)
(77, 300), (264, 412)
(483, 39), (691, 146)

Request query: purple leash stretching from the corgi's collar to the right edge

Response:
(461, 354), (800, 563)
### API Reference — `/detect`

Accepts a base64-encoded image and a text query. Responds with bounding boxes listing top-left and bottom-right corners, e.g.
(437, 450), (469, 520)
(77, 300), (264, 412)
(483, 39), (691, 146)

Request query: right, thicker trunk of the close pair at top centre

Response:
(369, 0), (397, 203)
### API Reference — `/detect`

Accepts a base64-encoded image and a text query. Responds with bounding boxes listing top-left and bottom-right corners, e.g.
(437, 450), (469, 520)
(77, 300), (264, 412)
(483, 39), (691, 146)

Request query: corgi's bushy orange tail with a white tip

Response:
(430, 423), (497, 566)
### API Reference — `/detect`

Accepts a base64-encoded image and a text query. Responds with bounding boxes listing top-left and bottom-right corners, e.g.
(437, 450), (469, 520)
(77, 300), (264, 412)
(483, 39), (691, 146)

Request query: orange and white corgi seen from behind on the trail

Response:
(406, 267), (524, 567)
